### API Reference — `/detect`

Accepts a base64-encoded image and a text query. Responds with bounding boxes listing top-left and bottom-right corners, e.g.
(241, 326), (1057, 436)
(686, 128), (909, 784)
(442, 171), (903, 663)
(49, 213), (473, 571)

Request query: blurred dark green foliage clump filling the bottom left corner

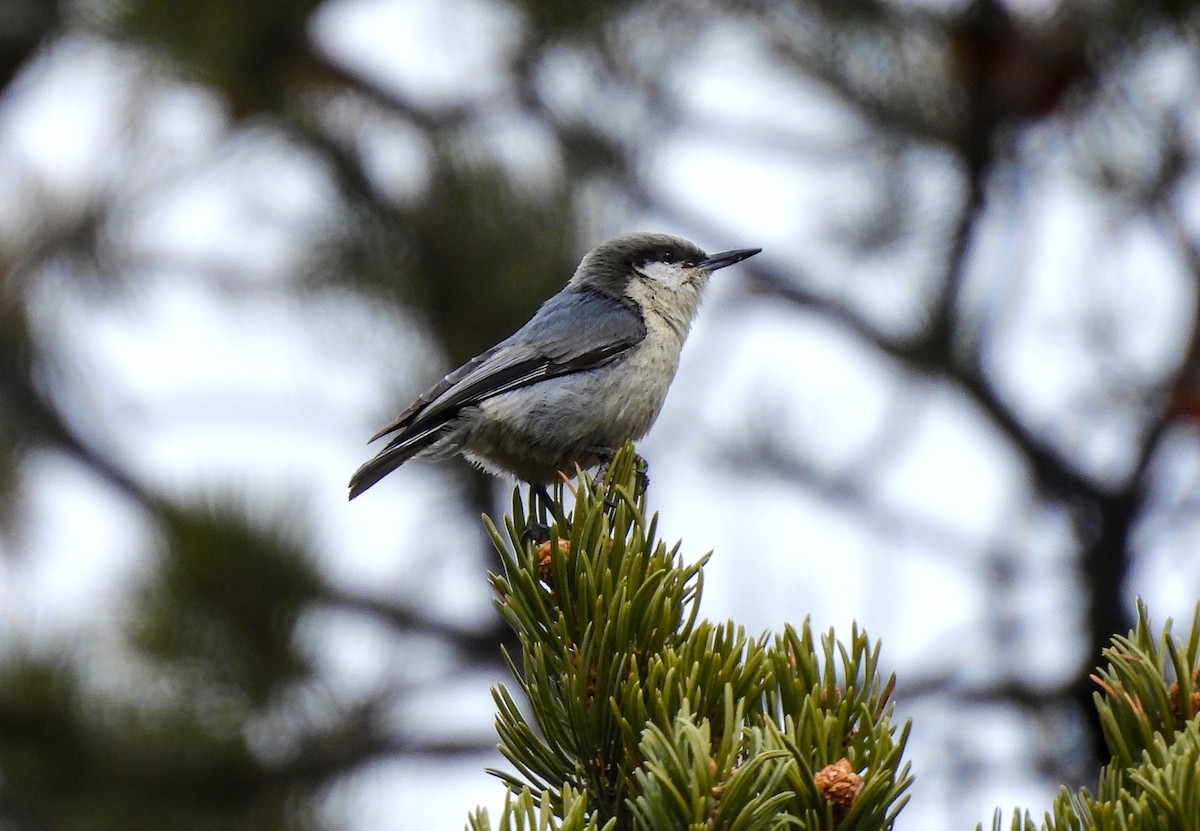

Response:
(0, 660), (324, 831)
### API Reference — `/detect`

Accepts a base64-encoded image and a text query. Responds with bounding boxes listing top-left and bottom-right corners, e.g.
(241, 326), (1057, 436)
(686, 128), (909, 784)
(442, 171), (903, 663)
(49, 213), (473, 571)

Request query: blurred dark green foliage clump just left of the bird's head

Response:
(326, 157), (578, 364)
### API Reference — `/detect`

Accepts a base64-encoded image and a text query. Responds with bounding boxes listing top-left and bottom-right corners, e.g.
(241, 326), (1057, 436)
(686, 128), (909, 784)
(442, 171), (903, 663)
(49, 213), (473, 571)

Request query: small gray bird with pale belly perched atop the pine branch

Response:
(349, 232), (762, 500)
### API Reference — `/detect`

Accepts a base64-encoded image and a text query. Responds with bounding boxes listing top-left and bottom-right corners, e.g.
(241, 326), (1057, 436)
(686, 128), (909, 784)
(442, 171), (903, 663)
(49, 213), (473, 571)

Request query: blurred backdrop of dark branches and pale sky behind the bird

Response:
(0, 0), (1200, 831)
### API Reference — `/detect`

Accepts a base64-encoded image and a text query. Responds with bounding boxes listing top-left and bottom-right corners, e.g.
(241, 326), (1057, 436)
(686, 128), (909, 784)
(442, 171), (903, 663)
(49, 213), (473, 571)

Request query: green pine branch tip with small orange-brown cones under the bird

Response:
(470, 446), (911, 831)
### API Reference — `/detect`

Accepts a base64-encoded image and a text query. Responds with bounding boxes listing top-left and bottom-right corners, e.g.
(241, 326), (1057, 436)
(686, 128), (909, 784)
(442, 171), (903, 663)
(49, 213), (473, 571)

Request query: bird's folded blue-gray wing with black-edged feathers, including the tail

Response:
(350, 288), (646, 498)
